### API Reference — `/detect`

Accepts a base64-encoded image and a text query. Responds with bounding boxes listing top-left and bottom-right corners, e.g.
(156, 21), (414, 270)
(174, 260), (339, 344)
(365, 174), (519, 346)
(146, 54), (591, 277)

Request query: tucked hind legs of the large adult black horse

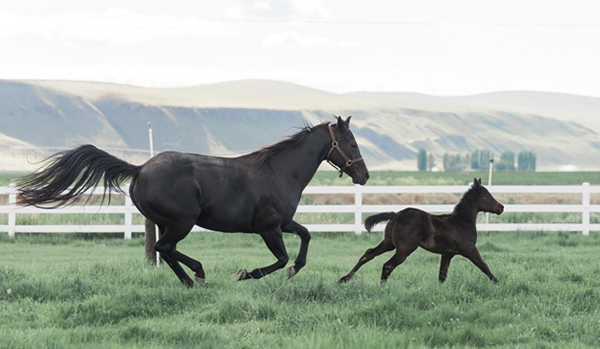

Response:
(154, 224), (205, 287)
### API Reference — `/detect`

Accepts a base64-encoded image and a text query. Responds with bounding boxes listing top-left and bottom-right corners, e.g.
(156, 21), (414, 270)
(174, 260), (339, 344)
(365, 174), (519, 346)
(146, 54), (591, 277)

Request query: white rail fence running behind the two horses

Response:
(0, 183), (600, 239)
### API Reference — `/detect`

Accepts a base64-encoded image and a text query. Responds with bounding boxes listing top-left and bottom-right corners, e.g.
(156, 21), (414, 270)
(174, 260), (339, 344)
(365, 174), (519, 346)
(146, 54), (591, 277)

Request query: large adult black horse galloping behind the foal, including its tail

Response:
(17, 117), (369, 287)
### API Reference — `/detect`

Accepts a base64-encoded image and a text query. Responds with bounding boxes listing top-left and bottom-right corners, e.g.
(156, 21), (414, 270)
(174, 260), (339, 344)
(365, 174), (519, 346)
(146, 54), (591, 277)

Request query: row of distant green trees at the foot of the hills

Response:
(417, 148), (537, 171)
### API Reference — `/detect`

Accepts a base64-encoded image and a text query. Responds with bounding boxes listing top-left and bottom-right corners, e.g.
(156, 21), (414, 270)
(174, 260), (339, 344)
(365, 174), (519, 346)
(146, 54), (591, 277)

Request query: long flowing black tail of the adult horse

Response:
(17, 144), (140, 208)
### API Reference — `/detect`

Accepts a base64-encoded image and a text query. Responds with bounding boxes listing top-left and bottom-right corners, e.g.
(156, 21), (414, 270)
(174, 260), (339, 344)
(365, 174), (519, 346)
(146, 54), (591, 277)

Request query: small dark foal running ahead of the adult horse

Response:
(339, 179), (504, 283)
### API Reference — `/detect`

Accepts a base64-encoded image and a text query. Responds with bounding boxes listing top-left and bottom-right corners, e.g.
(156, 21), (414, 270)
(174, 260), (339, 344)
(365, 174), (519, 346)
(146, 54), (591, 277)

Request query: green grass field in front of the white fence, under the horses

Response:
(0, 232), (600, 348)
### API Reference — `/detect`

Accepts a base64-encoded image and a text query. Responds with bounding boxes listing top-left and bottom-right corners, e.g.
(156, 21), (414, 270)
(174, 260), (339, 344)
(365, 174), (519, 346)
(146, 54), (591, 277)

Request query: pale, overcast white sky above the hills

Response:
(0, 0), (600, 97)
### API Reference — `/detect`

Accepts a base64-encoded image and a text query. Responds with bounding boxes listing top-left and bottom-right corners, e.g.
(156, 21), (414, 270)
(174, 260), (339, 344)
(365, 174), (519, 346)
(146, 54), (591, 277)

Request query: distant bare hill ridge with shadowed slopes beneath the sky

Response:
(0, 80), (600, 170)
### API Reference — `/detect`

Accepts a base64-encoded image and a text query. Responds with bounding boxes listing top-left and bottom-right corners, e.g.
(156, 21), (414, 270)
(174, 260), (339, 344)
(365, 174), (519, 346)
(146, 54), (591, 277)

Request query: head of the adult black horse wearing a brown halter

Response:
(327, 116), (369, 185)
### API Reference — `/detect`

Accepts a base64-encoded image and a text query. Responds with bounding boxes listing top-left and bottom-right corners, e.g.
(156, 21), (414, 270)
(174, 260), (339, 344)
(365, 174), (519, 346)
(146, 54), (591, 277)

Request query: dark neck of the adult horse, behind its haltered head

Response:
(269, 129), (331, 191)
